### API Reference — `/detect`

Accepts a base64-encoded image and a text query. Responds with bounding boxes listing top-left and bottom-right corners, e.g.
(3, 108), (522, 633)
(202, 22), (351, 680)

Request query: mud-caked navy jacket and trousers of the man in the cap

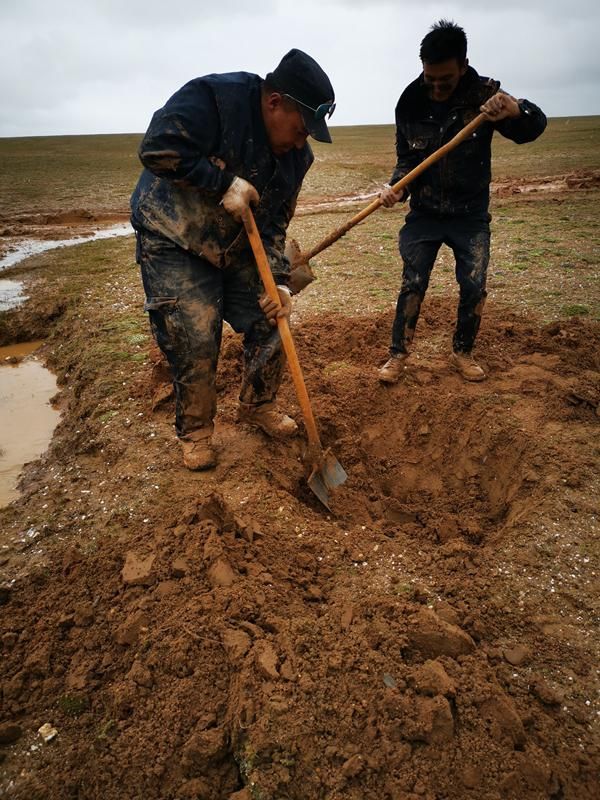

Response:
(131, 72), (313, 438)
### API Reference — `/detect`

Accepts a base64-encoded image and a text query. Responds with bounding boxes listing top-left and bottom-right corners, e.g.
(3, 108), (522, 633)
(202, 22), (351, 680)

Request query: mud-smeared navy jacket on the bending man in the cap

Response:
(131, 72), (313, 283)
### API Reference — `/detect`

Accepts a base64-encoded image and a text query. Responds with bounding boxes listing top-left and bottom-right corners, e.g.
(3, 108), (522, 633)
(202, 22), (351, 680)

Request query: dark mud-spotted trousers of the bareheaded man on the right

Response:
(390, 211), (490, 355)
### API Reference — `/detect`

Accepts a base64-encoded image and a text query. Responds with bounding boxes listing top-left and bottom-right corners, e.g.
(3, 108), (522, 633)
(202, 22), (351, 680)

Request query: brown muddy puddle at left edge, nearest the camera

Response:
(0, 342), (60, 508)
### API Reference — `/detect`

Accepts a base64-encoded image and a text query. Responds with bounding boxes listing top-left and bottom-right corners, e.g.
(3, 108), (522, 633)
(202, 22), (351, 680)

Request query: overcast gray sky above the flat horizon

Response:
(0, 0), (600, 136)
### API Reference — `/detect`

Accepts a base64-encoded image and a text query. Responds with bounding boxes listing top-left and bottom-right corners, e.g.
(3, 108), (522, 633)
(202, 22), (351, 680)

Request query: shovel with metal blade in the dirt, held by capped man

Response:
(242, 208), (348, 511)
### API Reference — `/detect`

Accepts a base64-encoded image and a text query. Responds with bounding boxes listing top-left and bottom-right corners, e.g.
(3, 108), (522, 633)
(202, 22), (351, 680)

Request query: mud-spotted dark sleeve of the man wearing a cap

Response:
(138, 79), (234, 195)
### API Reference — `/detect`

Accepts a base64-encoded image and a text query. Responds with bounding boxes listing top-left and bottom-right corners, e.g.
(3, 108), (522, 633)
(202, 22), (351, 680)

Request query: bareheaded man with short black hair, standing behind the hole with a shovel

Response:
(379, 20), (546, 383)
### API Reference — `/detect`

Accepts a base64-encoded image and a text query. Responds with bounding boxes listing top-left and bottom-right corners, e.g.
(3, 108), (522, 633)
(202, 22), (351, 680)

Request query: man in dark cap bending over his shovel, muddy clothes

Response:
(131, 49), (335, 470)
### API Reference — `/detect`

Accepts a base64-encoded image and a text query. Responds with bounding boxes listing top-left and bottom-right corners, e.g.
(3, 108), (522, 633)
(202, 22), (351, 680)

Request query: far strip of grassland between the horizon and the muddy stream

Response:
(0, 117), (600, 216)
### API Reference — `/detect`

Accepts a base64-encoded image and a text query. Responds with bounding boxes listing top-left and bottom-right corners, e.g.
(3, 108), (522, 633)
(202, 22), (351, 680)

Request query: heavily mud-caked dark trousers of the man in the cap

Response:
(137, 230), (283, 439)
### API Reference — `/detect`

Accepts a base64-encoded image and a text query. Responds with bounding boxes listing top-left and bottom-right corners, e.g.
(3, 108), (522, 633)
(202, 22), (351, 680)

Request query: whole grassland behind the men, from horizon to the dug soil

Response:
(0, 117), (600, 328)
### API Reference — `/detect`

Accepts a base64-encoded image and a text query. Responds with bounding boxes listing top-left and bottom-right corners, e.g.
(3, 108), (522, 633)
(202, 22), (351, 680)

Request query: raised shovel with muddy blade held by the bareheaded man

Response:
(286, 113), (488, 294)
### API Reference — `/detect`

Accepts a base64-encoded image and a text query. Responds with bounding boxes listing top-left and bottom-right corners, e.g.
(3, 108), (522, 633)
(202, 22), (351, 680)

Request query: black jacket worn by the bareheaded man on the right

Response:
(390, 67), (546, 218)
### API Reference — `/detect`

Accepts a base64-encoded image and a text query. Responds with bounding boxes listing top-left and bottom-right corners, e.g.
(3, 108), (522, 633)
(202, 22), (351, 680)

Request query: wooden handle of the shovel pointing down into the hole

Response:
(242, 208), (322, 451)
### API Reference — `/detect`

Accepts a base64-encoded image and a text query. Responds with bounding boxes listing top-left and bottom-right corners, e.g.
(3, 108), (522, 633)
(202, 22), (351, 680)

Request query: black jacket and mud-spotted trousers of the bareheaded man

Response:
(390, 67), (546, 354)
